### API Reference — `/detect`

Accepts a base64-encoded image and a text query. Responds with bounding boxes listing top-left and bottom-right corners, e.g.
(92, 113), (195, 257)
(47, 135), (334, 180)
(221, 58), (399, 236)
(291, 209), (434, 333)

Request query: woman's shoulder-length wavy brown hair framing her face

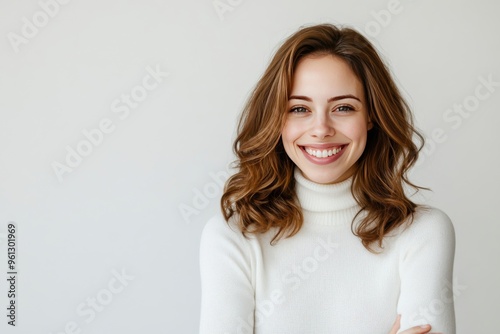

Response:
(221, 24), (424, 251)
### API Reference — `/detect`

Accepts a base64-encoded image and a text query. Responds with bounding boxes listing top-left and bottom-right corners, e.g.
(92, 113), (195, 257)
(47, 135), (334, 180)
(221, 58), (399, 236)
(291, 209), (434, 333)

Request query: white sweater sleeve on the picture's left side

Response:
(200, 216), (255, 334)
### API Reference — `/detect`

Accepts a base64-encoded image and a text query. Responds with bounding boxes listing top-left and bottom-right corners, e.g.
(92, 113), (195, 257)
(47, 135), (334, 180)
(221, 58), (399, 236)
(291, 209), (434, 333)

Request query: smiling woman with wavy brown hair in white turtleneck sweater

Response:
(200, 24), (455, 334)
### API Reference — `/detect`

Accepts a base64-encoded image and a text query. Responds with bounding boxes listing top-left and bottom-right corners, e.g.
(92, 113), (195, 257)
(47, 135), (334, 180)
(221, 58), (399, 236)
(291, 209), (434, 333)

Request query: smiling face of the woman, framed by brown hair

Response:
(281, 55), (372, 183)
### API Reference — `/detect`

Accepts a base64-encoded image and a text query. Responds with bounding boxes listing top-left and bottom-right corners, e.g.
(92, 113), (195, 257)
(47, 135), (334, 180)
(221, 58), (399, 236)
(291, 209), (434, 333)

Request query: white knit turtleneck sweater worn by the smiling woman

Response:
(200, 169), (455, 334)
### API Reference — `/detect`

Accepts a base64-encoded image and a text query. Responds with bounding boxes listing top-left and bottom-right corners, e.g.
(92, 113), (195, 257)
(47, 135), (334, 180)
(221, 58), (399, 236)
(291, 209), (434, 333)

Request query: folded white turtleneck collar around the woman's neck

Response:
(294, 168), (359, 225)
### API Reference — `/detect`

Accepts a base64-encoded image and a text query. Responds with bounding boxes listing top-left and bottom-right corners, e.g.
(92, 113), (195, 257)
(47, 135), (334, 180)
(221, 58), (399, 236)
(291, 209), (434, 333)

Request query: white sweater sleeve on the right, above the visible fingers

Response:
(397, 208), (455, 334)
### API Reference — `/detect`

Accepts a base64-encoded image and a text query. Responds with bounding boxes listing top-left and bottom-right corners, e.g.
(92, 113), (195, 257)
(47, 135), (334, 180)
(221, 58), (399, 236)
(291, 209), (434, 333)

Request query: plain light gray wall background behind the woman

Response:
(0, 0), (500, 334)
